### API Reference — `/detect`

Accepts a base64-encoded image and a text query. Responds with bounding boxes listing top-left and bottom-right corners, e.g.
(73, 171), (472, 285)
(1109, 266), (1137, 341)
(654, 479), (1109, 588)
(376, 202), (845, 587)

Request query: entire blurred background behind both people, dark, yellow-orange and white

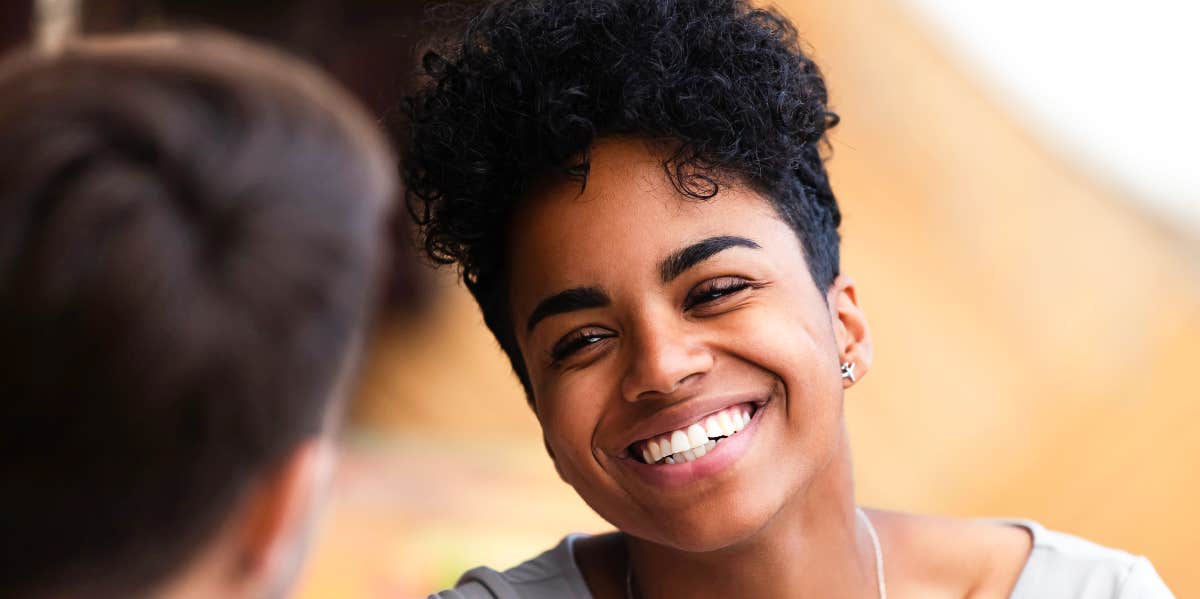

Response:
(0, 0), (1200, 599)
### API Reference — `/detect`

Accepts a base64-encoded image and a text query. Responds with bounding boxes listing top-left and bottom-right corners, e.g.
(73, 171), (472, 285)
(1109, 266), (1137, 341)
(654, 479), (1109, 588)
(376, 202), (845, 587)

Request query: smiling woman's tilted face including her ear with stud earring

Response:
(510, 139), (869, 551)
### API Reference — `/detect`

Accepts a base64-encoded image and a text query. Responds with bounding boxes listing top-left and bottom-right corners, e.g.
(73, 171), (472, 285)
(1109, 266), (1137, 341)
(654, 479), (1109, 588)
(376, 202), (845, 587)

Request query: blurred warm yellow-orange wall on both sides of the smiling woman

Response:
(295, 0), (1200, 598)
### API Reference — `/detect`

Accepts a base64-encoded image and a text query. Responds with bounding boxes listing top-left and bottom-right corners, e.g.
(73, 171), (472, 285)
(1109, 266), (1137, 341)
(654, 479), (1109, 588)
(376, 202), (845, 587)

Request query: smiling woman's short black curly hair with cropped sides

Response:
(400, 0), (841, 402)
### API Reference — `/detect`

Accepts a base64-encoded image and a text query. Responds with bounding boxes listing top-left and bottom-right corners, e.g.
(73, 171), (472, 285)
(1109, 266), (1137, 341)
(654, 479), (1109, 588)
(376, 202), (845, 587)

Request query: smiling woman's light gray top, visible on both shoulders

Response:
(430, 521), (1175, 599)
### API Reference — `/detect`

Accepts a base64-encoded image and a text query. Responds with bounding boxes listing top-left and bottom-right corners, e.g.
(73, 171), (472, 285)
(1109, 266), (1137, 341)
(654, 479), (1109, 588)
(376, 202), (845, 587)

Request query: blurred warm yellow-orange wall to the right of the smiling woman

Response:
(782, 0), (1200, 597)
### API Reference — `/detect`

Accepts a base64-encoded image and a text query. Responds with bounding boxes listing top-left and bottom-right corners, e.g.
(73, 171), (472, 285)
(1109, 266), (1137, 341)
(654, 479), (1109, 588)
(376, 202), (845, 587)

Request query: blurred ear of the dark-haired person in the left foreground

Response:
(240, 437), (335, 587)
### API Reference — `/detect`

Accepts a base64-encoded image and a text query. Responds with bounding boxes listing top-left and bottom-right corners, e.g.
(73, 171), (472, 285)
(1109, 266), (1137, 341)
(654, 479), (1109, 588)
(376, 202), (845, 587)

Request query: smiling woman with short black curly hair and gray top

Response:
(402, 0), (1171, 598)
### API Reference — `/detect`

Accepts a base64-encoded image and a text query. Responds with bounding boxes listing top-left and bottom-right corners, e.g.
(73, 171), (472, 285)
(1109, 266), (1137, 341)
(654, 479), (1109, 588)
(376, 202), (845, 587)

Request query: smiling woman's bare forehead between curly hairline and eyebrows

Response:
(510, 140), (791, 292)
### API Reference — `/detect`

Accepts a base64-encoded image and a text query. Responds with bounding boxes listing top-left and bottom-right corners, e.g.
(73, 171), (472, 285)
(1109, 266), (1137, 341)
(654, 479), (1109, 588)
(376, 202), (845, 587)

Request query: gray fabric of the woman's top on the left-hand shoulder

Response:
(430, 534), (592, 599)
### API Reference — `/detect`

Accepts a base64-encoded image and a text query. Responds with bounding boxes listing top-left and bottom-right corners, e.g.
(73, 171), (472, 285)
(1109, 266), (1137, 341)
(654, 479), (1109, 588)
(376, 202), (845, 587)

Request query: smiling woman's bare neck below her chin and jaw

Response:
(626, 437), (878, 599)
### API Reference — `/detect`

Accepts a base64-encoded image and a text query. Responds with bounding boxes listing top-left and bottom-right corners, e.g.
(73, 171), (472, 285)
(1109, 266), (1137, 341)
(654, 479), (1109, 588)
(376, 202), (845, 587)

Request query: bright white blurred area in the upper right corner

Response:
(902, 0), (1200, 244)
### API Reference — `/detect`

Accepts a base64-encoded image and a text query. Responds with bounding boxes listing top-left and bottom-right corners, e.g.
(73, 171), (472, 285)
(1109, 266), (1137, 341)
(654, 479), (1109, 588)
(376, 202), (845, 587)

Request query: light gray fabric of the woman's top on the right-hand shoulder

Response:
(1003, 520), (1175, 599)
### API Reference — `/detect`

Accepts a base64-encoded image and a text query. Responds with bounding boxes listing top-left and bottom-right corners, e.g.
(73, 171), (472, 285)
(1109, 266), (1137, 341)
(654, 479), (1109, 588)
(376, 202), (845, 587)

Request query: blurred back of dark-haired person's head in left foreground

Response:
(0, 34), (395, 597)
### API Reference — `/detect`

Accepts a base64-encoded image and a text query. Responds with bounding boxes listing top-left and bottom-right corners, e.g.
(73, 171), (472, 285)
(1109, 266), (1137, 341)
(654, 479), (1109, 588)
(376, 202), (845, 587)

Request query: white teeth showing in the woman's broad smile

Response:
(629, 403), (755, 466)
